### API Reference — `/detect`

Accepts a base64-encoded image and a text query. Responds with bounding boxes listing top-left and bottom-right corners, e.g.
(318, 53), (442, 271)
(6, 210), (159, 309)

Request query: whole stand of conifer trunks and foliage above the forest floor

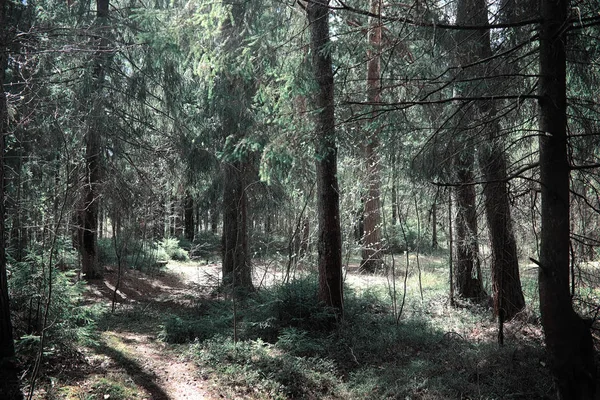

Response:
(0, 0), (600, 399)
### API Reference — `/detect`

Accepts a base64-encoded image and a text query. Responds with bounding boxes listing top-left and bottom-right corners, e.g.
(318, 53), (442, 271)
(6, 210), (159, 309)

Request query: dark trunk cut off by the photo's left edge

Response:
(0, 0), (22, 400)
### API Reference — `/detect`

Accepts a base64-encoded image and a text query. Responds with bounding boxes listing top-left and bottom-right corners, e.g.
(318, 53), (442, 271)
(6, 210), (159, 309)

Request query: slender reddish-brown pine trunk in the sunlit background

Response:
(361, 0), (382, 272)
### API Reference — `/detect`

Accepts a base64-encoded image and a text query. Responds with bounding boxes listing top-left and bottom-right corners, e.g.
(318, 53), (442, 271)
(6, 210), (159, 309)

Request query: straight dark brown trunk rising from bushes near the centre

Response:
(306, 0), (344, 315)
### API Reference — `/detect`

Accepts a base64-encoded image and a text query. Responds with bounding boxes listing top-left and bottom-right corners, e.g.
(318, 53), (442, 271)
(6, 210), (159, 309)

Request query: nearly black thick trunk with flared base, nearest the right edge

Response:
(539, 0), (598, 400)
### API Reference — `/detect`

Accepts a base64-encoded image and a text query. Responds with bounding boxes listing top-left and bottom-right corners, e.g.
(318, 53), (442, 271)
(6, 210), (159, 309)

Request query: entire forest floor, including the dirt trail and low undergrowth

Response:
(27, 257), (568, 400)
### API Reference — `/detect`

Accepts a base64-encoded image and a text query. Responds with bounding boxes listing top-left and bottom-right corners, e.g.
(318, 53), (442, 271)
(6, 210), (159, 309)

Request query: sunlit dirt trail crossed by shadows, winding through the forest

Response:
(78, 263), (220, 400)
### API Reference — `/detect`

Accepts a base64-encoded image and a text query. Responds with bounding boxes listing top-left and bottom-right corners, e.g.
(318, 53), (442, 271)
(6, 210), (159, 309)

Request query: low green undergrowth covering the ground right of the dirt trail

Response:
(160, 256), (551, 399)
